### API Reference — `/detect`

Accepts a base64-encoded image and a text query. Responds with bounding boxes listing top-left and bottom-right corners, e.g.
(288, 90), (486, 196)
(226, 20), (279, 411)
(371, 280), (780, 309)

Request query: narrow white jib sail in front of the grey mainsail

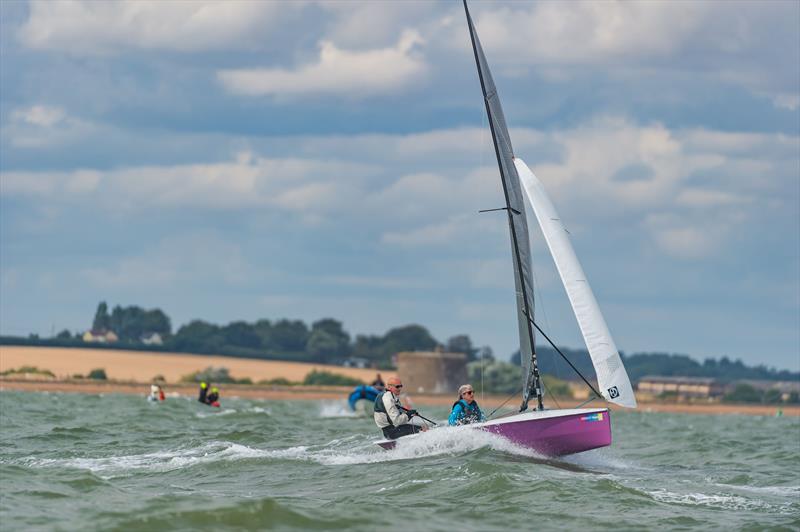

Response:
(514, 158), (636, 408)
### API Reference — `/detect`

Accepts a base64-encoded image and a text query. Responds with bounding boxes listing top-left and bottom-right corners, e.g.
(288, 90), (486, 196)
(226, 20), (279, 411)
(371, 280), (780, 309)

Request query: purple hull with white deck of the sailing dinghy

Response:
(377, 408), (611, 456)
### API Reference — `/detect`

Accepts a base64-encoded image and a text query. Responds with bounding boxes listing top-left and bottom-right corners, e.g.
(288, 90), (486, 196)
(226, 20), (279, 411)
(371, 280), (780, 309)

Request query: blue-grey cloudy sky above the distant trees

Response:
(0, 0), (800, 370)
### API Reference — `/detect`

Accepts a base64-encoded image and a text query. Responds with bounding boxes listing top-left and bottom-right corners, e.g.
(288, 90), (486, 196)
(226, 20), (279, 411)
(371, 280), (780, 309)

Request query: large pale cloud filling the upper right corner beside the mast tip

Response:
(447, 0), (800, 111)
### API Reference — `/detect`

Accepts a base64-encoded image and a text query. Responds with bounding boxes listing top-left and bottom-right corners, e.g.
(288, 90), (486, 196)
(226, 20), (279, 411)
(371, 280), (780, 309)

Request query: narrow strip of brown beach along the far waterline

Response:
(0, 377), (800, 417)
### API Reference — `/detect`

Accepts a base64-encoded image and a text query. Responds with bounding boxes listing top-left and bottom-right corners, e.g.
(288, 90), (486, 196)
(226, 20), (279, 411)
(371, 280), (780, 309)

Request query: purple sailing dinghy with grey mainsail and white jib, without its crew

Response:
(376, 0), (636, 456)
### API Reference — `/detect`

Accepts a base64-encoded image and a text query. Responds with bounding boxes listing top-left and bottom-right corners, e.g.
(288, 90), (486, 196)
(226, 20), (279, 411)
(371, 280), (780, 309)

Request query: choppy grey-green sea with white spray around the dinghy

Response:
(0, 392), (800, 531)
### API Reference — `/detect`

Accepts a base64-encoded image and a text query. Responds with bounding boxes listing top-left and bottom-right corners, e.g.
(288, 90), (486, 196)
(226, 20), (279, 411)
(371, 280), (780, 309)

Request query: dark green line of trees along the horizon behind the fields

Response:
(6, 302), (800, 380)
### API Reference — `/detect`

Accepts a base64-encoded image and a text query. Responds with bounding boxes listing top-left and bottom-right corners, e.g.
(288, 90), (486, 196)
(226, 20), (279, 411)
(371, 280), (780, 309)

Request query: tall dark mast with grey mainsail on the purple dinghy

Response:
(463, 0), (544, 412)
